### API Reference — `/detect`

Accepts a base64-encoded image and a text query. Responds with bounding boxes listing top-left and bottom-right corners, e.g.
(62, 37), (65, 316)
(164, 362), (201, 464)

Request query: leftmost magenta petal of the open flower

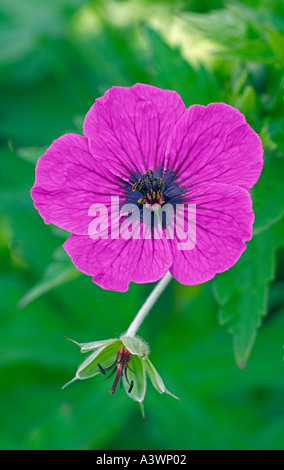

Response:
(31, 134), (123, 235)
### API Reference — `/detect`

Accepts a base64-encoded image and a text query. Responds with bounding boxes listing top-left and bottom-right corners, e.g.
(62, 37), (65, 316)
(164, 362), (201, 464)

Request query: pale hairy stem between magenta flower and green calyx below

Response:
(125, 272), (172, 337)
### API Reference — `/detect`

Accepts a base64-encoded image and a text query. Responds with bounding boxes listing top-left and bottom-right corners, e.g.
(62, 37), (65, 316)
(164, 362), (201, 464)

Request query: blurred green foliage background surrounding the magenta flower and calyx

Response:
(0, 0), (284, 450)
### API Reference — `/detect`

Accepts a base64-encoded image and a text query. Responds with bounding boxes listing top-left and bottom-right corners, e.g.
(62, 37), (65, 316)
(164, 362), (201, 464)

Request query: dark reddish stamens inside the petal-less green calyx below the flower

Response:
(98, 346), (134, 395)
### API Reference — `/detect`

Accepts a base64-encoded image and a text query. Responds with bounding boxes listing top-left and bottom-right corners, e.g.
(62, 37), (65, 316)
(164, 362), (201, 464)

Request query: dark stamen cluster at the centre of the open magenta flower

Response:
(132, 170), (164, 206)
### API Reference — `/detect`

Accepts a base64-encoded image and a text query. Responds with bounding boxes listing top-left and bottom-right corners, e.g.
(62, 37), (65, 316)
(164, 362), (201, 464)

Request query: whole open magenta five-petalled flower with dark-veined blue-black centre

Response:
(31, 84), (263, 291)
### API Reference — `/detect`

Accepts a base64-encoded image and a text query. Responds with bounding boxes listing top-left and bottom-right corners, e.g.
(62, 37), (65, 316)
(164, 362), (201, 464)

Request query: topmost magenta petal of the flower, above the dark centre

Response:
(84, 83), (185, 180)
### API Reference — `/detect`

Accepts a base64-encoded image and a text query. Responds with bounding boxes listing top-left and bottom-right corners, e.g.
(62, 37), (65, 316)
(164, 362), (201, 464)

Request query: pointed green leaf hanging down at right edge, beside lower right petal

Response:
(214, 219), (284, 368)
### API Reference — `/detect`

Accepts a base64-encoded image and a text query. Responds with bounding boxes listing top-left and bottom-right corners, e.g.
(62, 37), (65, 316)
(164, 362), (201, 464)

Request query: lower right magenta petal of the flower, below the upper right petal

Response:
(170, 183), (254, 285)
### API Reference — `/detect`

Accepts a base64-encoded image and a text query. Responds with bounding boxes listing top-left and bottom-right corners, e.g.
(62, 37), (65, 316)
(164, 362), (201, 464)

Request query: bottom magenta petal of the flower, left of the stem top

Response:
(64, 226), (172, 292)
